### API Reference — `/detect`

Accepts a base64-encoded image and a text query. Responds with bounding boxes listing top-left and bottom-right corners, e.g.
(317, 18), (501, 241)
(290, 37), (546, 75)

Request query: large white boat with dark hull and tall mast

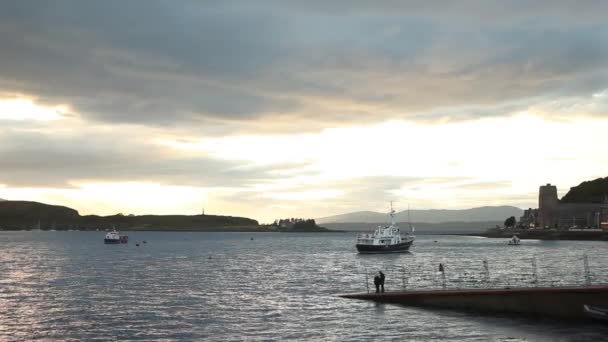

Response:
(356, 203), (416, 254)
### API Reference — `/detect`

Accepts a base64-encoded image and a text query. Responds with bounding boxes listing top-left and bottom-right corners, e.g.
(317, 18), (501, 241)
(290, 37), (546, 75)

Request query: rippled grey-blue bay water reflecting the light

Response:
(0, 231), (608, 341)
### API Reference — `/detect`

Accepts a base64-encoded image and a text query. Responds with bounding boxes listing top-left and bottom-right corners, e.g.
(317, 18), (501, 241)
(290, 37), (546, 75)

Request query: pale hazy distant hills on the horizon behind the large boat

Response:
(317, 206), (523, 224)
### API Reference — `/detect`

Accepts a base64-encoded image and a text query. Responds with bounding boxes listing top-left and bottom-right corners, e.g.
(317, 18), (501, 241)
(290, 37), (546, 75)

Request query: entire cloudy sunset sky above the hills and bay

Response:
(0, 0), (608, 223)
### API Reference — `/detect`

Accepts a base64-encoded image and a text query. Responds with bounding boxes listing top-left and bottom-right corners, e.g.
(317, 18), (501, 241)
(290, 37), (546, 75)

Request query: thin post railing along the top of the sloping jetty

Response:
(362, 254), (608, 292)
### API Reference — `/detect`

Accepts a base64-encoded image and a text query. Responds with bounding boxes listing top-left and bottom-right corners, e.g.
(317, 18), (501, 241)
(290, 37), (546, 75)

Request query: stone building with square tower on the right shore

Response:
(532, 183), (608, 228)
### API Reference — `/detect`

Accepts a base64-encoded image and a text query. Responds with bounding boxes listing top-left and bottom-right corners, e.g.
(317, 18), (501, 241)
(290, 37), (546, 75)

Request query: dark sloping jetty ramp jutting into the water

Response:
(340, 285), (608, 320)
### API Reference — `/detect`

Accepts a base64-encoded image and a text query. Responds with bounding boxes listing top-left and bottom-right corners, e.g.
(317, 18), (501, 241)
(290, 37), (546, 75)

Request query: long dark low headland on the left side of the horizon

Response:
(0, 201), (262, 231)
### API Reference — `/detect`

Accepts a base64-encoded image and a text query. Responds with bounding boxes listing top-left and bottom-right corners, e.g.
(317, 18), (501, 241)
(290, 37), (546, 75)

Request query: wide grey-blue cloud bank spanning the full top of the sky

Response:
(0, 0), (608, 133)
